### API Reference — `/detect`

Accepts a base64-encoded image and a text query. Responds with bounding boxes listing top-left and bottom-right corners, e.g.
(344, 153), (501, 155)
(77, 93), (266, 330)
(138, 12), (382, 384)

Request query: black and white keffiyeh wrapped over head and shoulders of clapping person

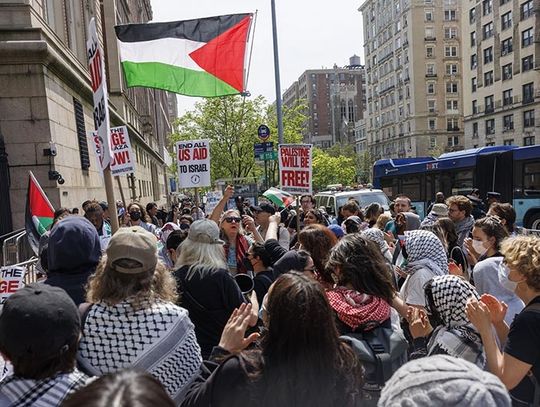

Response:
(428, 275), (486, 368)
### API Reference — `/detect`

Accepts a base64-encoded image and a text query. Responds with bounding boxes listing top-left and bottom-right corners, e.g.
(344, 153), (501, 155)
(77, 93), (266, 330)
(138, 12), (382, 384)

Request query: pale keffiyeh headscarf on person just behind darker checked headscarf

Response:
(403, 230), (448, 276)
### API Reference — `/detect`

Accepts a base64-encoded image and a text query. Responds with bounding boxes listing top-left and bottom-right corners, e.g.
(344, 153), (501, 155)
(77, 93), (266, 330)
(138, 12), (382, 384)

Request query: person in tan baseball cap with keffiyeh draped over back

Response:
(77, 226), (202, 405)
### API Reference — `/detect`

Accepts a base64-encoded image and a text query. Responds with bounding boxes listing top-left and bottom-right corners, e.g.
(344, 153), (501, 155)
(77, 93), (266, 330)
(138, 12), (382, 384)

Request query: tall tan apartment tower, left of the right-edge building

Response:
(359, 0), (464, 159)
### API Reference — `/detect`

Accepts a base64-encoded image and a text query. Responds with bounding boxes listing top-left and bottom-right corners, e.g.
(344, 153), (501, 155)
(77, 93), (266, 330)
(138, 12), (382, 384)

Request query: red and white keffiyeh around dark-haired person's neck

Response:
(326, 287), (390, 331)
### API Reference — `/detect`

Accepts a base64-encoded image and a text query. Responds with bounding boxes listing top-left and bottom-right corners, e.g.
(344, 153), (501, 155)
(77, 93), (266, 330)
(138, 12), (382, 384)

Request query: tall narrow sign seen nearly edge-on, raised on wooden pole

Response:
(86, 17), (112, 170)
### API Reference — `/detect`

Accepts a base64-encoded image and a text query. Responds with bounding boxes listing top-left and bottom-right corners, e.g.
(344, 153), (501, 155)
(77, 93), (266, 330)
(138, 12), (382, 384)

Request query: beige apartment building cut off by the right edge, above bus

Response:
(461, 0), (540, 148)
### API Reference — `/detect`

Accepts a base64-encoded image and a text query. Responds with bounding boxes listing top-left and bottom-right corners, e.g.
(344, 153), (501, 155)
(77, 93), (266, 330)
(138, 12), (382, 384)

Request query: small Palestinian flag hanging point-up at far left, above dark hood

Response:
(25, 172), (54, 254)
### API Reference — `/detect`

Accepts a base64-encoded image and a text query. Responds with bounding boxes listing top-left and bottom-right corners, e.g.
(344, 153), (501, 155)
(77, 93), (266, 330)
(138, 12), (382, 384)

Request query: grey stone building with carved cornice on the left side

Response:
(0, 0), (176, 234)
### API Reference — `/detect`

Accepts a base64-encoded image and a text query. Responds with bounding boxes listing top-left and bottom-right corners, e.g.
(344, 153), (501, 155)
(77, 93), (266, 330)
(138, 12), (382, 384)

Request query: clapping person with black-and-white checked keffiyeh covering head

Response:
(408, 275), (486, 369)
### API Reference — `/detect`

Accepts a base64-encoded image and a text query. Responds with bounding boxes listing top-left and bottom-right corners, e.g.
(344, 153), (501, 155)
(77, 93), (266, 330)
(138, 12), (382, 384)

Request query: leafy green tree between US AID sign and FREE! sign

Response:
(170, 96), (266, 181)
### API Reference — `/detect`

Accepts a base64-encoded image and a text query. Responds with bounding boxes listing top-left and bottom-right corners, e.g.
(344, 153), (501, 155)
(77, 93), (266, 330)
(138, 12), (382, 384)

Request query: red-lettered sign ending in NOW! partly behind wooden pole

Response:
(88, 126), (135, 176)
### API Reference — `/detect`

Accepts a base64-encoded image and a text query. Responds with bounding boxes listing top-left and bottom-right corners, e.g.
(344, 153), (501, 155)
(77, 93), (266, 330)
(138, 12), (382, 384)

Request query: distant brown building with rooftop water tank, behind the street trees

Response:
(283, 55), (366, 148)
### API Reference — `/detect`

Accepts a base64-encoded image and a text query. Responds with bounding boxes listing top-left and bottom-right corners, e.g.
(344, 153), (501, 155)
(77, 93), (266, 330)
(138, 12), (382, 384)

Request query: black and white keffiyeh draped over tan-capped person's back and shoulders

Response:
(77, 300), (202, 404)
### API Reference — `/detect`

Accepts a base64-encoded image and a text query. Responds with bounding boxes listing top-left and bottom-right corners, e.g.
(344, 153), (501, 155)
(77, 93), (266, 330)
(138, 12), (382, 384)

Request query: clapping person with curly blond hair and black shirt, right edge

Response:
(467, 236), (540, 406)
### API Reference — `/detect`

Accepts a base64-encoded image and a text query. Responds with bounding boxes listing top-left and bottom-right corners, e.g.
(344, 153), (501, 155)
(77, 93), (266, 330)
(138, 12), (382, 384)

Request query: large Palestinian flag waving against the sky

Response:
(115, 14), (252, 97)
